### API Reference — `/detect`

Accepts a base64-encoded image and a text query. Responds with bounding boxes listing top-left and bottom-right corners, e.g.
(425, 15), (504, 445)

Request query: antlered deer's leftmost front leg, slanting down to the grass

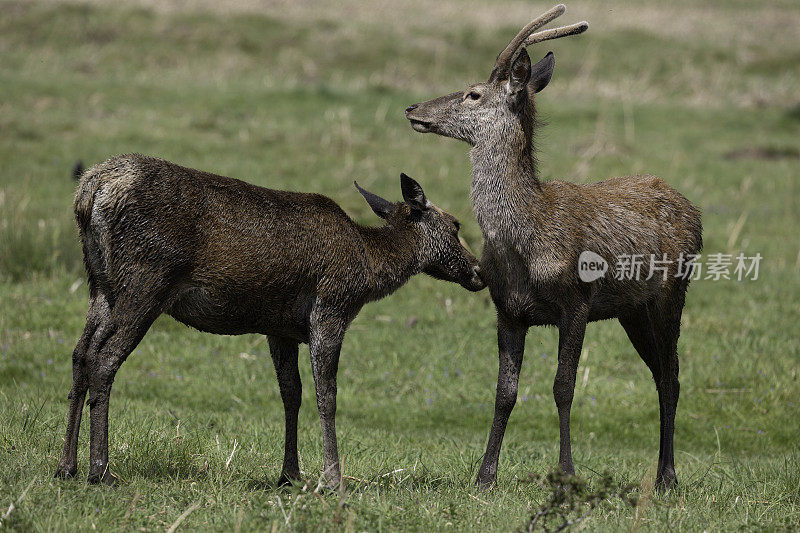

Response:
(475, 313), (528, 488)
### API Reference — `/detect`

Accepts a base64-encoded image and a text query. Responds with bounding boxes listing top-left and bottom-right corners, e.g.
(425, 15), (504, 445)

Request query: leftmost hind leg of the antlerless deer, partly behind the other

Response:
(54, 293), (109, 478)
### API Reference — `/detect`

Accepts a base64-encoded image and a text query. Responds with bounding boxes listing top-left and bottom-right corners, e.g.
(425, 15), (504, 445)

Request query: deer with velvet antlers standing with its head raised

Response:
(406, 5), (702, 487)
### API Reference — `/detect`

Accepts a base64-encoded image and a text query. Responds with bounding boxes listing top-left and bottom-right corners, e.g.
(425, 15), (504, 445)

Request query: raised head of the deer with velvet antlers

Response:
(406, 4), (589, 146)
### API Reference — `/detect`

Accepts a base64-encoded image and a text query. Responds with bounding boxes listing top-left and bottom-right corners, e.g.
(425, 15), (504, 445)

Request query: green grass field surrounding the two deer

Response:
(0, 0), (800, 531)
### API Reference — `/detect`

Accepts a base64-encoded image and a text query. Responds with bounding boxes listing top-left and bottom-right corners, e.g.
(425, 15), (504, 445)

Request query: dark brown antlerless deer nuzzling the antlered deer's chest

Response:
(56, 155), (484, 486)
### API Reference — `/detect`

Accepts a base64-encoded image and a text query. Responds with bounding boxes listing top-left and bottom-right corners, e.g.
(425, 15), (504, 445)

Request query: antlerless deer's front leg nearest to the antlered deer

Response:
(311, 317), (344, 489)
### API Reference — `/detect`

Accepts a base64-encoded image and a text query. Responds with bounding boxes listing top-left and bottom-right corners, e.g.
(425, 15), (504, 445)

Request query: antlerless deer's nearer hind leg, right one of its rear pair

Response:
(86, 288), (166, 484)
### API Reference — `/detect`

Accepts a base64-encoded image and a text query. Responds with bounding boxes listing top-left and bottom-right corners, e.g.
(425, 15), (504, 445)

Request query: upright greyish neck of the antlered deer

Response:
(470, 120), (541, 242)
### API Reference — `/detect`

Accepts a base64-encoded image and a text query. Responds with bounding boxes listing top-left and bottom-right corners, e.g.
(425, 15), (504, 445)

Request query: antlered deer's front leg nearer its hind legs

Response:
(553, 305), (589, 474)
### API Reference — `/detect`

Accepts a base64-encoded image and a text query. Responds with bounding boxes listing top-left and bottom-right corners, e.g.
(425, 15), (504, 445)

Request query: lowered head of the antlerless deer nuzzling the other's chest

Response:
(353, 174), (486, 291)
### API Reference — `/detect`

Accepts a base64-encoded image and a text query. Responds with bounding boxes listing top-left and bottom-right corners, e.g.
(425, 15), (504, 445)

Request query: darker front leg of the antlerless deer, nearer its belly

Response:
(267, 336), (303, 485)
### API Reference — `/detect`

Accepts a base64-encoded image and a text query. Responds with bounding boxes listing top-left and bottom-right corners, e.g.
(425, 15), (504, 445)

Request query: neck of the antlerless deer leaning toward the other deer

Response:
(359, 224), (421, 300)
